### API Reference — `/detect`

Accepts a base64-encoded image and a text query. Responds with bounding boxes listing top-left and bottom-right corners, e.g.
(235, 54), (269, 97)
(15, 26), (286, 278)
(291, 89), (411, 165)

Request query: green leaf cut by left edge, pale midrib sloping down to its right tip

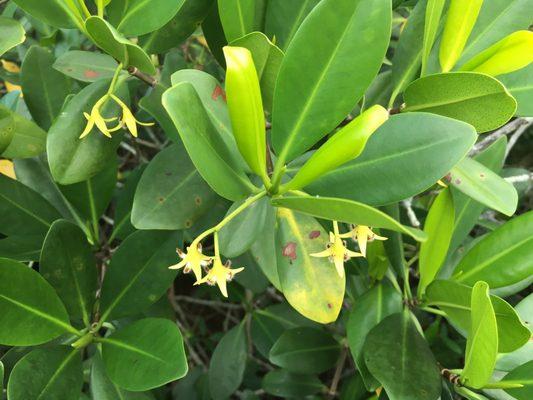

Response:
(0, 258), (77, 346)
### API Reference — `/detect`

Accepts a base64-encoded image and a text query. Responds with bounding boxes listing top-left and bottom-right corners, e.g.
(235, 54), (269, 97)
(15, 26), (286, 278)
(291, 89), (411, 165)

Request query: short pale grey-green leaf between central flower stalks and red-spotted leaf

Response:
(219, 198), (270, 257)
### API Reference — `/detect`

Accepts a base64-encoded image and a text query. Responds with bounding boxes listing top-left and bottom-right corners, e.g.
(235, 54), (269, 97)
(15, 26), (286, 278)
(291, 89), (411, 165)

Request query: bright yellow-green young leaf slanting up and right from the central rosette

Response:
(282, 105), (389, 191)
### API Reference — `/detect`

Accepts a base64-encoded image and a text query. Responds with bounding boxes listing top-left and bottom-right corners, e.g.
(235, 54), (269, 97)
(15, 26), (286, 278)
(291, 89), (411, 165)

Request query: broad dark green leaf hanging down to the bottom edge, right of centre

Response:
(363, 311), (441, 400)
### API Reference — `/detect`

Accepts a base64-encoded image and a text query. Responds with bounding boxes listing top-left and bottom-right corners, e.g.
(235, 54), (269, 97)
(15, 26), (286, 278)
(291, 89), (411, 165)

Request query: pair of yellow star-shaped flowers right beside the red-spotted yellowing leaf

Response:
(310, 221), (387, 277)
